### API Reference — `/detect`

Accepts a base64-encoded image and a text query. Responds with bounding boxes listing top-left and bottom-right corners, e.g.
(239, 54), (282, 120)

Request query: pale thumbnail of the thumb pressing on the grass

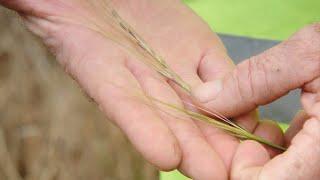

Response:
(192, 79), (223, 103)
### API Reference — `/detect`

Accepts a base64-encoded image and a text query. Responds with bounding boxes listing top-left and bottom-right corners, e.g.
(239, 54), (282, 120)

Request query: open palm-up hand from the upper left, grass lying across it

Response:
(0, 0), (260, 180)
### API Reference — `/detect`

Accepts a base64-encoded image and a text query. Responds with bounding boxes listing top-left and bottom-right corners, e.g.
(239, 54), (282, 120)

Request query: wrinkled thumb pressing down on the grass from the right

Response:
(193, 24), (320, 117)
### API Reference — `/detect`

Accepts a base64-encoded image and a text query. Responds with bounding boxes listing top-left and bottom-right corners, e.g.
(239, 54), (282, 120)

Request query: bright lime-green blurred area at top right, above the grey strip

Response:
(184, 0), (320, 40)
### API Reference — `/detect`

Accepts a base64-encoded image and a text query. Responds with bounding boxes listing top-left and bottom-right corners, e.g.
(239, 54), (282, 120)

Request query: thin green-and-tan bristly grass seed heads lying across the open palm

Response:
(94, 1), (286, 151)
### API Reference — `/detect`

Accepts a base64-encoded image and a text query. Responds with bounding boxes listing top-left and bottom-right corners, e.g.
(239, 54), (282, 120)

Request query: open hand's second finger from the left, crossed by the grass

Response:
(127, 59), (227, 179)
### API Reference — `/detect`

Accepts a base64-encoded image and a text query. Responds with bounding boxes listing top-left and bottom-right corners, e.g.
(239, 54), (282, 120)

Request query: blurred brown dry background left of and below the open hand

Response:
(0, 8), (158, 180)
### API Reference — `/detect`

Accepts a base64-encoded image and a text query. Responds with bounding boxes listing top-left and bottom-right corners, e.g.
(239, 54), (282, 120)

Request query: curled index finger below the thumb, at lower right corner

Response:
(231, 118), (320, 180)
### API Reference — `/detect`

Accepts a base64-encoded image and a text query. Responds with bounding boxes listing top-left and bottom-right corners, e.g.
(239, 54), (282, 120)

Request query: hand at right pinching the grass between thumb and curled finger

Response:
(194, 24), (320, 180)
